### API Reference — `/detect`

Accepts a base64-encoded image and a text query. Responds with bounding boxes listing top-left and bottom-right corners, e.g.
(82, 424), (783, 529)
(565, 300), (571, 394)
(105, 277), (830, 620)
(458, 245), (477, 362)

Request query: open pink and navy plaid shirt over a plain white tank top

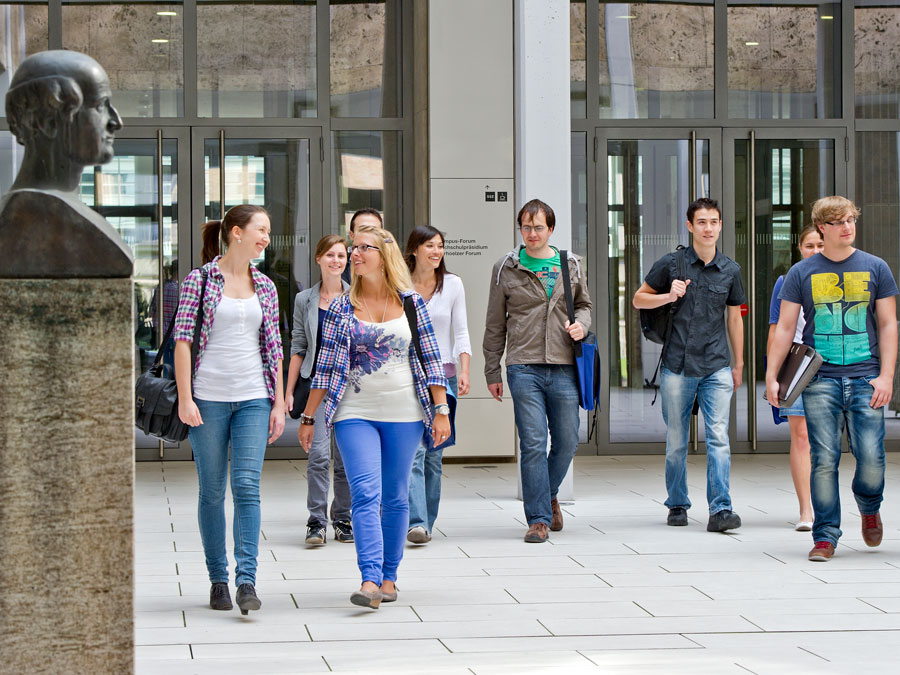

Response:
(173, 256), (284, 403)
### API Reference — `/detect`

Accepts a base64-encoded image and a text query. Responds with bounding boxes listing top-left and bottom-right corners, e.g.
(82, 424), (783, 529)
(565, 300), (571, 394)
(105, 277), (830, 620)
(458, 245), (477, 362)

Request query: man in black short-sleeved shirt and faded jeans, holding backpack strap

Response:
(632, 198), (746, 532)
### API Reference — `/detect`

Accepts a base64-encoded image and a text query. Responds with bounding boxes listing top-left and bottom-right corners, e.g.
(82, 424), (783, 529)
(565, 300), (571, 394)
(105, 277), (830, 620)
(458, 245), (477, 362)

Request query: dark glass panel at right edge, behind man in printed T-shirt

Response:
(856, 131), (900, 438)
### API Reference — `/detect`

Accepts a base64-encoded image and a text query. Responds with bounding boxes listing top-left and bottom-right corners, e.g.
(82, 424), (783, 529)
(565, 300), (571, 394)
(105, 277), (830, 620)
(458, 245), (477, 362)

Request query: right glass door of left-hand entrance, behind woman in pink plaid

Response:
(192, 128), (326, 458)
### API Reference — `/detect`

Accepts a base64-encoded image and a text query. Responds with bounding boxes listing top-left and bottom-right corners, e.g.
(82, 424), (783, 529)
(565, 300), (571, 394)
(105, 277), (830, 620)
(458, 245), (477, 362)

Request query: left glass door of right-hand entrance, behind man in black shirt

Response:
(594, 129), (721, 453)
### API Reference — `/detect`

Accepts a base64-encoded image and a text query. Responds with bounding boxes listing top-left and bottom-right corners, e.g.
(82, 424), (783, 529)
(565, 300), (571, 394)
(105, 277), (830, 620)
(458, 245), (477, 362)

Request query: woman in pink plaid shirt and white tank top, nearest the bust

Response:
(174, 204), (284, 614)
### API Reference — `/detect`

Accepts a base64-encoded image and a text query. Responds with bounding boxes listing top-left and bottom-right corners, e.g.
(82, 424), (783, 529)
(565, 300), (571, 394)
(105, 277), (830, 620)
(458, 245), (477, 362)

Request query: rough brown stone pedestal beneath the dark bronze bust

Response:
(0, 278), (134, 674)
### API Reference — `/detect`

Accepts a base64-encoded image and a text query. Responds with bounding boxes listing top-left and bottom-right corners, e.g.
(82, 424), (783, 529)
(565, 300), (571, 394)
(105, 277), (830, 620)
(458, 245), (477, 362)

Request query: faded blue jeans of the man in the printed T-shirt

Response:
(803, 375), (884, 546)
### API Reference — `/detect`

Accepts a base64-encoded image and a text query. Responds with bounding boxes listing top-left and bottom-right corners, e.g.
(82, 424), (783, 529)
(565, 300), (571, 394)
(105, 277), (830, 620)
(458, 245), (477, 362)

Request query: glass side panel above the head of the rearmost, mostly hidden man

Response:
(331, 131), (402, 236)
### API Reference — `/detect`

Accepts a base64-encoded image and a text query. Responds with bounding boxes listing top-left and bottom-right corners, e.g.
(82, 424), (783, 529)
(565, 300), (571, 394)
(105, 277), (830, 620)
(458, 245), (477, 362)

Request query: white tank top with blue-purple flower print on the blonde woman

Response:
(332, 315), (424, 422)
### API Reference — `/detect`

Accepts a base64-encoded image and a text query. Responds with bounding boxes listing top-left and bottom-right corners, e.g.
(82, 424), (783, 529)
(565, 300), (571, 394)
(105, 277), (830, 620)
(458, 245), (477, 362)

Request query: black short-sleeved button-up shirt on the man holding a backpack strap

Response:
(644, 246), (747, 377)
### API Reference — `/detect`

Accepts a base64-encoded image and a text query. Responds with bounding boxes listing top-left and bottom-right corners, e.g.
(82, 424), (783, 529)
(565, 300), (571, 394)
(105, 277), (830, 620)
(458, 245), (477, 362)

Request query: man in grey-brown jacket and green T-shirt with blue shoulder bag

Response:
(482, 199), (591, 543)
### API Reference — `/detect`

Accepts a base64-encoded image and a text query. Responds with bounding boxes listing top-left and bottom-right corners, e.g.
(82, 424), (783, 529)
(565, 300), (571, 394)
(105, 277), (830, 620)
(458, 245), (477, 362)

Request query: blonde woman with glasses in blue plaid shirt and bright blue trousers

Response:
(299, 226), (450, 609)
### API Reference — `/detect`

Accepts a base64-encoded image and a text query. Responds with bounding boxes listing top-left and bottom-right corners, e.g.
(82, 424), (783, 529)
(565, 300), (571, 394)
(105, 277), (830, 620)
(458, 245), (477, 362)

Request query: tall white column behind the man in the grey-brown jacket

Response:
(514, 0), (574, 500)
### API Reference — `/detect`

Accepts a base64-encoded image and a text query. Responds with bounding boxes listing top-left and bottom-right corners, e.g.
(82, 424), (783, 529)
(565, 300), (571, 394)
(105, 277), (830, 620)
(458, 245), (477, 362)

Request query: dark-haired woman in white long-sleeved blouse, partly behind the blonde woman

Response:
(404, 225), (472, 544)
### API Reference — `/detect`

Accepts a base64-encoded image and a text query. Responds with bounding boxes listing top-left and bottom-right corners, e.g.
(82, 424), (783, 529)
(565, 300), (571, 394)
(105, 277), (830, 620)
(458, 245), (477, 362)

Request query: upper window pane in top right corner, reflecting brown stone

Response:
(853, 0), (900, 120)
